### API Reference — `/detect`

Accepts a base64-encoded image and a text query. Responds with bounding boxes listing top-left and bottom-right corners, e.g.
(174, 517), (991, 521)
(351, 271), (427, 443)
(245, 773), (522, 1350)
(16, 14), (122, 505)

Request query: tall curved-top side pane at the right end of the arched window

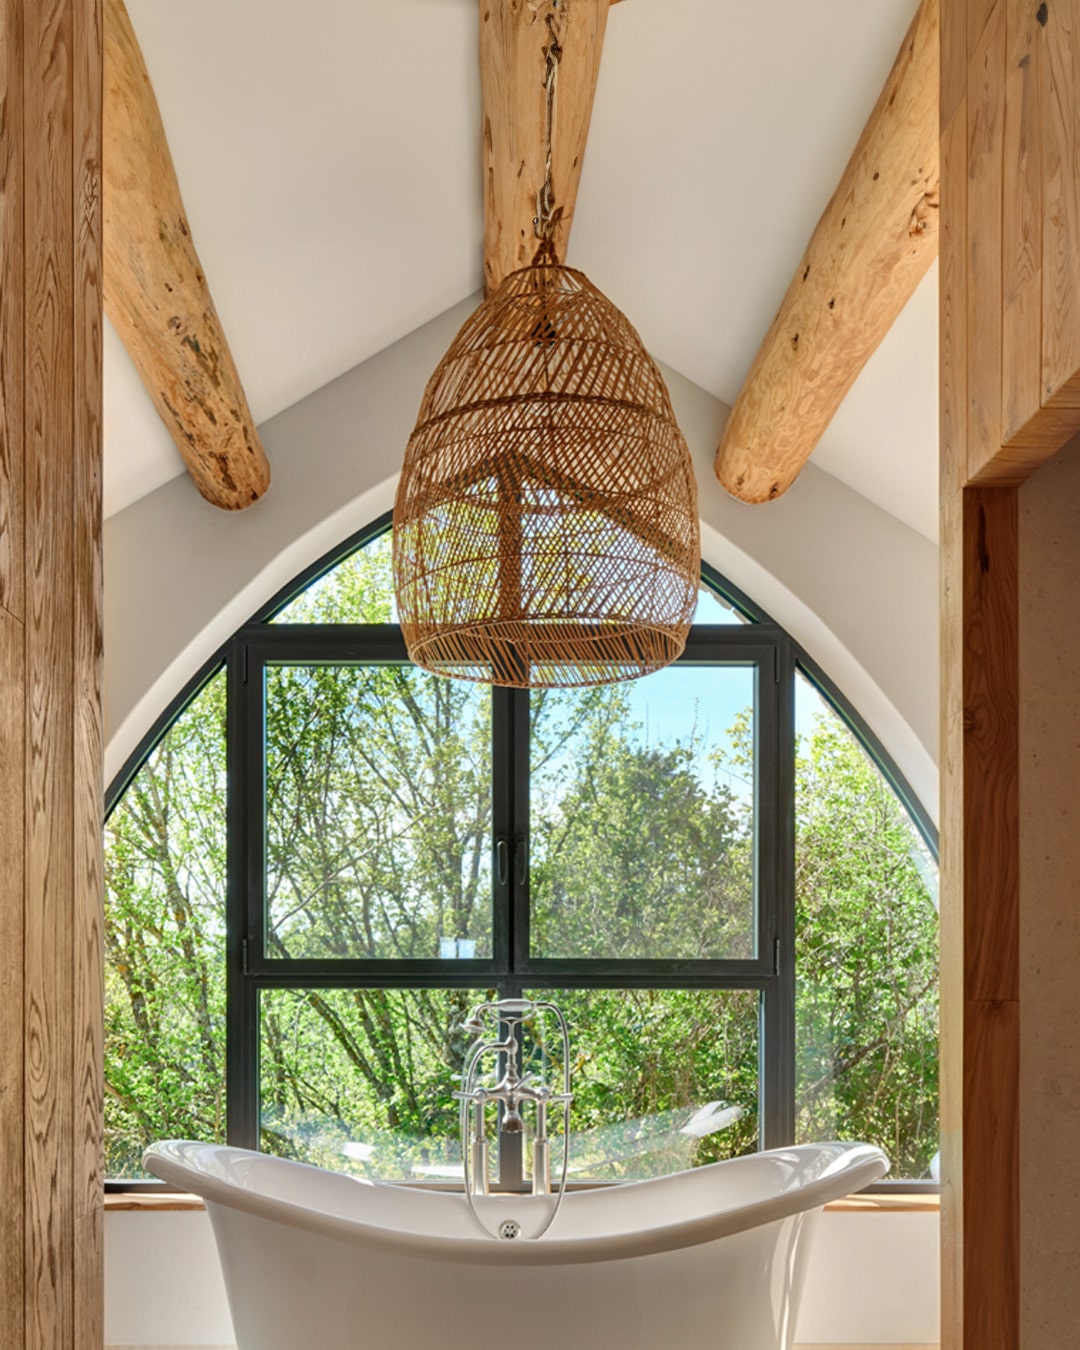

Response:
(795, 678), (938, 1179)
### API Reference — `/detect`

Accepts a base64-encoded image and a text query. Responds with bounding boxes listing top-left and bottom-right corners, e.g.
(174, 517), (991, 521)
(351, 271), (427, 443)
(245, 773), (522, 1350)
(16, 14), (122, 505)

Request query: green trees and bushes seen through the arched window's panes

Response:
(105, 539), (937, 1176)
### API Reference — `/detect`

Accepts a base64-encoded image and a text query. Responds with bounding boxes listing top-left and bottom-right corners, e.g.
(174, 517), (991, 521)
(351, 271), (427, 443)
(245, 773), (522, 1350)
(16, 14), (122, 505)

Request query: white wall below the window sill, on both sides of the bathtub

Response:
(105, 1211), (940, 1347)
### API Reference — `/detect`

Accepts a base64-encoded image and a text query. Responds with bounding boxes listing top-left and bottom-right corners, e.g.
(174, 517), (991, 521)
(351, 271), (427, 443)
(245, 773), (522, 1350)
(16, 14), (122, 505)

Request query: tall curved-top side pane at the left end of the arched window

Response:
(105, 674), (225, 1179)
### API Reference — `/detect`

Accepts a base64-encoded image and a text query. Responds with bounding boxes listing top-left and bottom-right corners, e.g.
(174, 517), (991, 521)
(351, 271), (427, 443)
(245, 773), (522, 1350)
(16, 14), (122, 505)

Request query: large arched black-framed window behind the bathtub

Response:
(105, 521), (937, 1187)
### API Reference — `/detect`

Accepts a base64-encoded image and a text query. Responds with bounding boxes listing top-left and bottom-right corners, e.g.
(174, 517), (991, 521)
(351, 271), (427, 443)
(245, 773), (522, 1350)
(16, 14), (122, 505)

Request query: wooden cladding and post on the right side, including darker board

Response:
(940, 0), (1080, 1350)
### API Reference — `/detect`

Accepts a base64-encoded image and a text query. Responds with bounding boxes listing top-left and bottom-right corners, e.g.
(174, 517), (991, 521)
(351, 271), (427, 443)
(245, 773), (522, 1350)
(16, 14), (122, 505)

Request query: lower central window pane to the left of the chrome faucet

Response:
(259, 990), (485, 1180)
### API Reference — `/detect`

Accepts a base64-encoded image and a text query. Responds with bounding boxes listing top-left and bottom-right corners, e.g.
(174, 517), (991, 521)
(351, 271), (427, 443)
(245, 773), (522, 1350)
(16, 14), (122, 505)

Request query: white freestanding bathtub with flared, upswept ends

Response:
(146, 1142), (888, 1350)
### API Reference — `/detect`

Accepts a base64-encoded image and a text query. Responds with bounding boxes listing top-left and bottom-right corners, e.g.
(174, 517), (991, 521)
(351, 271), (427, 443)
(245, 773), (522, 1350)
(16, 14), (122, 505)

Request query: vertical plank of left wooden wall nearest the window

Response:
(70, 0), (105, 1350)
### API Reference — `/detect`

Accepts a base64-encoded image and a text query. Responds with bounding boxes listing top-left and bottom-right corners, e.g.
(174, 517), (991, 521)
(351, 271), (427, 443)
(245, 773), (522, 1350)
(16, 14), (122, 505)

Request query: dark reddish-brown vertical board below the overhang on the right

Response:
(961, 487), (1019, 1350)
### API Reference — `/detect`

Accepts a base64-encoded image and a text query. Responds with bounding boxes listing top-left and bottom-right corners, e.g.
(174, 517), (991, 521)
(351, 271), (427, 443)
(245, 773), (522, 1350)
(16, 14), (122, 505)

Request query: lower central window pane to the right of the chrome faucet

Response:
(524, 990), (759, 1181)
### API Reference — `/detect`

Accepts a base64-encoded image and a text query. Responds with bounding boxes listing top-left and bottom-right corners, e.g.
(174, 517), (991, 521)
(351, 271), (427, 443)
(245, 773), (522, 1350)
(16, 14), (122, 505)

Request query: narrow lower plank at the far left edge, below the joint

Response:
(0, 612), (26, 1350)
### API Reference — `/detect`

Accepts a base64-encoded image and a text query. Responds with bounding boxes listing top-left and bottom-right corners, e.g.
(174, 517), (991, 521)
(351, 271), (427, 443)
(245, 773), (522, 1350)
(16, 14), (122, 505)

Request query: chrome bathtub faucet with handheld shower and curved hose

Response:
(454, 999), (574, 1237)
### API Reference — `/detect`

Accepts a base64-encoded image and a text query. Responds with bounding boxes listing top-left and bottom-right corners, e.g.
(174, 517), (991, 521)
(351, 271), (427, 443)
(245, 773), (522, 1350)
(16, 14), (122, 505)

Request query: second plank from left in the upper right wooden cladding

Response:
(967, 0), (1006, 477)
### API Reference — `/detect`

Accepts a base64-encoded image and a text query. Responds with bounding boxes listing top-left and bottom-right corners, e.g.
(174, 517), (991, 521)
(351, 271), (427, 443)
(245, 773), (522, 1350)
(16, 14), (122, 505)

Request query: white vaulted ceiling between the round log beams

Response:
(105, 0), (937, 537)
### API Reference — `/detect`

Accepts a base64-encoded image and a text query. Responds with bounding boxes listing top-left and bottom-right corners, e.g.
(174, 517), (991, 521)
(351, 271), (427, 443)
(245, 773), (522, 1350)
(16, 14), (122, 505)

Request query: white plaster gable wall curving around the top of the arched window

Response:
(105, 300), (937, 815)
